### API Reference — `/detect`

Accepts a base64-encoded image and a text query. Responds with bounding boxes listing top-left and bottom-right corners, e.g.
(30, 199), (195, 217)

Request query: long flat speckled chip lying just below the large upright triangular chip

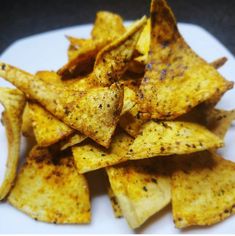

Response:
(128, 121), (223, 160)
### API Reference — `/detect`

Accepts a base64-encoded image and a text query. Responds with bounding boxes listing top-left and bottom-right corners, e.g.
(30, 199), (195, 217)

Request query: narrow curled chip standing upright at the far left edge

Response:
(0, 87), (25, 200)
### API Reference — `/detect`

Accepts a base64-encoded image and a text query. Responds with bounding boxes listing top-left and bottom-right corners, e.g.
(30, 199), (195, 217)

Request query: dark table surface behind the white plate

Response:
(0, 0), (235, 54)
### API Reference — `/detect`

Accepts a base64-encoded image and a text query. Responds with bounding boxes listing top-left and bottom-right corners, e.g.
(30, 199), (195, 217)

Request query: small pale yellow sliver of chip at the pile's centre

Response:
(121, 86), (136, 115)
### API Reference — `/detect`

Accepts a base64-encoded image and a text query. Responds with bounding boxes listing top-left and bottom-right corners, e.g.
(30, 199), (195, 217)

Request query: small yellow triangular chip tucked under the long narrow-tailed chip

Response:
(29, 102), (75, 147)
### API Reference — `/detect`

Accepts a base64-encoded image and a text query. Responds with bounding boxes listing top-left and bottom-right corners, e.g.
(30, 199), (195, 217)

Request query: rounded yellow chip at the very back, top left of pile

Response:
(91, 11), (126, 41)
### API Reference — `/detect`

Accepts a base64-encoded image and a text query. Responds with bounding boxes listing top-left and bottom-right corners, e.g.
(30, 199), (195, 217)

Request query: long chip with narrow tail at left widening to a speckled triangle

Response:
(0, 63), (123, 147)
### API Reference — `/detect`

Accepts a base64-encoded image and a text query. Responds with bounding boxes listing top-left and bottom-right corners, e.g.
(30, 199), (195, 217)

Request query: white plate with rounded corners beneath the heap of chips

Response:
(0, 24), (235, 234)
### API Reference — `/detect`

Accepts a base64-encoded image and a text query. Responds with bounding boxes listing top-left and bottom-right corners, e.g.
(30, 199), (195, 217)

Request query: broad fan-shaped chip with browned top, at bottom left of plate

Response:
(8, 149), (91, 224)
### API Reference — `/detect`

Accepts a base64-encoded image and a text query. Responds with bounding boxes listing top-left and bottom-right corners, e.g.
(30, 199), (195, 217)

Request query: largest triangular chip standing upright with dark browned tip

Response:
(139, 0), (233, 120)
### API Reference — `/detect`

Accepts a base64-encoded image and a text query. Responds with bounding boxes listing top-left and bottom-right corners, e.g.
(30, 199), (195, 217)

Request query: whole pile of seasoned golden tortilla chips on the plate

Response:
(0, 0), (235, 228)
